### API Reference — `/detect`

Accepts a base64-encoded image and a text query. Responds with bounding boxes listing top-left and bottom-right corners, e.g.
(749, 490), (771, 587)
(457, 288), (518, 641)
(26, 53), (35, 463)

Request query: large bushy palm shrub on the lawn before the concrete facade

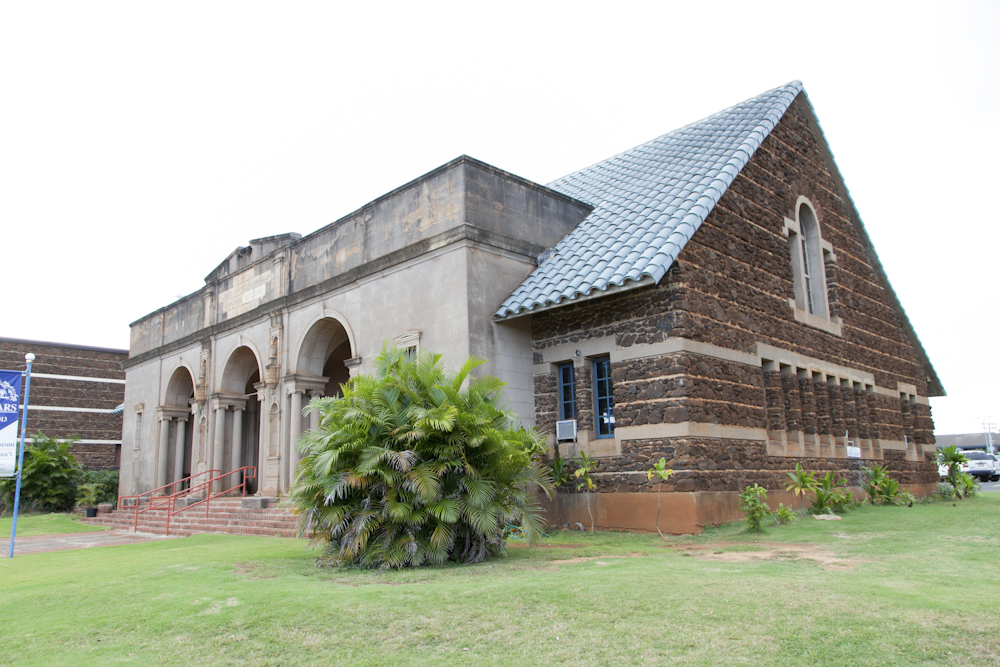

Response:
(290, 346), (552, 568)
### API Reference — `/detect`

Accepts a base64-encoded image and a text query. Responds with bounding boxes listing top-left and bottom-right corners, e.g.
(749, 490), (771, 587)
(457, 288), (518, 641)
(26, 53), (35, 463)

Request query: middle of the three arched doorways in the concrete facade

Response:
(220, 345), (261, 495)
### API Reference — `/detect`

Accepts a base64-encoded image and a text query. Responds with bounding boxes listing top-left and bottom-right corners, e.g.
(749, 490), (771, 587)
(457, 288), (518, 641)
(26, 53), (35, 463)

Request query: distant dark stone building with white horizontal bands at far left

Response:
(0, 338), (128, 470)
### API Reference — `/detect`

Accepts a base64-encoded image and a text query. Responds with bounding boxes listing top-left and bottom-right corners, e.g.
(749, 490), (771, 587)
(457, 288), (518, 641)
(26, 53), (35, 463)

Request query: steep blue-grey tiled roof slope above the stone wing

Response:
(496, 81), (802, 318)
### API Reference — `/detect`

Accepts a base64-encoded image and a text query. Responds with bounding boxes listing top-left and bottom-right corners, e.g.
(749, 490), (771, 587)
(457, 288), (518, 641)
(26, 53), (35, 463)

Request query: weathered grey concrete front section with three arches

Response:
(120, 157), (590, 497)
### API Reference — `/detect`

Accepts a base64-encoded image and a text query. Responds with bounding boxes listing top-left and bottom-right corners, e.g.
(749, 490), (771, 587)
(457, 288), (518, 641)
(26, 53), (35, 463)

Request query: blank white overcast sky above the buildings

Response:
(0, 0), (1000, 433)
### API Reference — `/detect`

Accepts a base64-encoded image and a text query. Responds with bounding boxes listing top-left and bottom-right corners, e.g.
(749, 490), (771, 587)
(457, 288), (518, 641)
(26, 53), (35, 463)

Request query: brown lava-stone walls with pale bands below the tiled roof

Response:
(532, 96), (937, 532)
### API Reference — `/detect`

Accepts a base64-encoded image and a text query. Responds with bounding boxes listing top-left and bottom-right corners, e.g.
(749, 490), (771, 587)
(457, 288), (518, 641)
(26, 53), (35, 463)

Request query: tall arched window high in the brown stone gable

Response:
(785, 197), (839, 333)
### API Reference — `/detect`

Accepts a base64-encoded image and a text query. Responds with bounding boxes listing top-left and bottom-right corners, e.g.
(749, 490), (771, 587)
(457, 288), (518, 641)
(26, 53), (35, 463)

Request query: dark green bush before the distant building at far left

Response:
(0, 431), (82, 512)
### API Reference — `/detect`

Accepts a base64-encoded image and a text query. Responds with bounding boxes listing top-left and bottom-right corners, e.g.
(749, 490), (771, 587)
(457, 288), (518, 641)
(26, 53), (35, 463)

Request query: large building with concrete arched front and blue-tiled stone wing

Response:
(122, 82), (944, 532)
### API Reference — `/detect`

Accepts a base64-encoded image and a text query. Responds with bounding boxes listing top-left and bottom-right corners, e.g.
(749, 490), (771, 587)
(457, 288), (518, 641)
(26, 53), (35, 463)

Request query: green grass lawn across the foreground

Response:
(0, 494), (1000, 667)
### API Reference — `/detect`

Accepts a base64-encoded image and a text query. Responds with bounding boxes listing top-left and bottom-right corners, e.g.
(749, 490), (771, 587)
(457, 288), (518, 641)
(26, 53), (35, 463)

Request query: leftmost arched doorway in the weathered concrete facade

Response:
(157, 366), (194, 492)
